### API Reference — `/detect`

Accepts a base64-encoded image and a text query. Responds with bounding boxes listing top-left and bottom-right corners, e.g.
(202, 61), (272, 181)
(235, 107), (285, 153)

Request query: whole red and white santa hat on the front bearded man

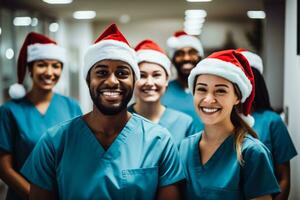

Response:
(83, 24), (140, 80)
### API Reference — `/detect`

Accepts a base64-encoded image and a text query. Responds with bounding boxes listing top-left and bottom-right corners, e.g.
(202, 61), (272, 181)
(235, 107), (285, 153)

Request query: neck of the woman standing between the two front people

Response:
(133, 100), (166, 123)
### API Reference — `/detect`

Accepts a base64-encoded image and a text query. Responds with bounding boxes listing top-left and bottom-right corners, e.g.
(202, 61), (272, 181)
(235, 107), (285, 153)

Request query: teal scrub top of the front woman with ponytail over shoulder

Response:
(180, 132), (280, 200)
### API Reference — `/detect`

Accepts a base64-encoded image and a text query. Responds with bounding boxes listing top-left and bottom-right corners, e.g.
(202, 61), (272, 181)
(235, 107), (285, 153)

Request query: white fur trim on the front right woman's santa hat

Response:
(188, 58), (252, 103)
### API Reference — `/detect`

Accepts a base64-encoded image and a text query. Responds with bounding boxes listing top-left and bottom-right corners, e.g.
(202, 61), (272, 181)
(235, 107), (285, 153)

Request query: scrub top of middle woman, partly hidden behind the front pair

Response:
(128, 104), (197, 147)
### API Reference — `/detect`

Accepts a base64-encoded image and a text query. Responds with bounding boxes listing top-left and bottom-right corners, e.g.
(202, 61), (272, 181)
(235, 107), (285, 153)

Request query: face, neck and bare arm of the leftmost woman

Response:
(0, 60), (62, 199)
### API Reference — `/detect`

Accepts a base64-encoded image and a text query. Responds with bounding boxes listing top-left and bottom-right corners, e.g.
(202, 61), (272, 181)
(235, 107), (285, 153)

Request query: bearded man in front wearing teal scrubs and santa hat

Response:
(21, 24), (184, 200)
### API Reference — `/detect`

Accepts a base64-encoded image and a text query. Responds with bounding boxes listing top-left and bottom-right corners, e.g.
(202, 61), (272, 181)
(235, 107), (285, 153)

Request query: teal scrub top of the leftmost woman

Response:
(0, 93), (81, 199)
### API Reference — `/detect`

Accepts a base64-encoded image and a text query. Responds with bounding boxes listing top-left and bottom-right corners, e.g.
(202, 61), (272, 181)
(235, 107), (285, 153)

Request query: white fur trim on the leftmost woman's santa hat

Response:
(27, 43), (66, 63)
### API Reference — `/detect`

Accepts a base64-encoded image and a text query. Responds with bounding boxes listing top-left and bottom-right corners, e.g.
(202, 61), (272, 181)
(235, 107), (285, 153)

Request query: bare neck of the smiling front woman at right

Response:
(203, 121), (234, 144)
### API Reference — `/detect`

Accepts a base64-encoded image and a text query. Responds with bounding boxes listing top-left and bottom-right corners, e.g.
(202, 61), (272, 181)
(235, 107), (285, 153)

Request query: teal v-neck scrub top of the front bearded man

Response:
(21, 114), (185, 200)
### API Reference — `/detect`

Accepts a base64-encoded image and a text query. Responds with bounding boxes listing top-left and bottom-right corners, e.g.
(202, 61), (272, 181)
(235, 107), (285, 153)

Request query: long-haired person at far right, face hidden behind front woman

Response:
(238, 49), (297, 200)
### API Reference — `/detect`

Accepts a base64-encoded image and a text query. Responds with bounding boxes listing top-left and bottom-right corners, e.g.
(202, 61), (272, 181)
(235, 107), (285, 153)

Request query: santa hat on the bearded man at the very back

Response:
(167, 31), (204, 57)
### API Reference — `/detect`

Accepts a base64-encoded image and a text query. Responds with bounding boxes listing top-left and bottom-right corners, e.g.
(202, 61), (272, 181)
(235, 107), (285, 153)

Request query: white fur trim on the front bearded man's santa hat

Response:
(83, 40), (140, 80)
